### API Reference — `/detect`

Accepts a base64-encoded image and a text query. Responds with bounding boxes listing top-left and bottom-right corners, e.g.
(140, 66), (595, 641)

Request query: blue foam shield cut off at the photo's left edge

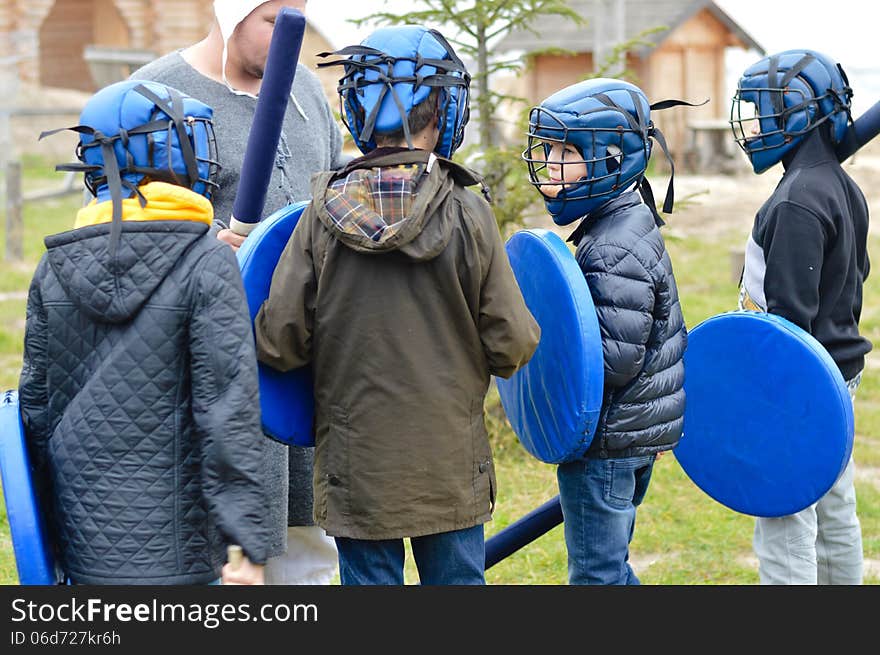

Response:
(0, 391), (58, 585)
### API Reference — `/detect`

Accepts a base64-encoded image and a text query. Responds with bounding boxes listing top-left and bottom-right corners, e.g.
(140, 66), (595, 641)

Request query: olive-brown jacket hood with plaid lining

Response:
(312, 149), (482, 261)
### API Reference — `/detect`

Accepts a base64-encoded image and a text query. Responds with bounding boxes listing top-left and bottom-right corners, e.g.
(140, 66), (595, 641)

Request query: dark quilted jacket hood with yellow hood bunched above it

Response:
(45, 183), (211, 323)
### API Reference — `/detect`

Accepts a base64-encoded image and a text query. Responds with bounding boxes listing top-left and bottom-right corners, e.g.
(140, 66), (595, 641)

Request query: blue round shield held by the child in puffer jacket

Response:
(497, 229), (604, 464)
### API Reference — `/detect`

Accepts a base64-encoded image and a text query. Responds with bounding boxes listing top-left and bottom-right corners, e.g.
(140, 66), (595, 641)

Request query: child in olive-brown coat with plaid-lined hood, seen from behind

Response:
(255, 25), (539, 585)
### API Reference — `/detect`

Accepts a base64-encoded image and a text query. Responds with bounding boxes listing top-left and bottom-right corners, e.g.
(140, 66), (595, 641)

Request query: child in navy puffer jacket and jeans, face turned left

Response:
(523, 79), (687, 585)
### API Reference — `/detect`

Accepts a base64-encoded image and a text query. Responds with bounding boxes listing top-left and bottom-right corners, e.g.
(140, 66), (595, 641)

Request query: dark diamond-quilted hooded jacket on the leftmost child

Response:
(19, 221), (266, 584)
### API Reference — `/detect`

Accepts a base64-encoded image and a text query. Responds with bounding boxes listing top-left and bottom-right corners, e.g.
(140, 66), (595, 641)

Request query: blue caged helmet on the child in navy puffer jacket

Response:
(522, 78), (671, 225)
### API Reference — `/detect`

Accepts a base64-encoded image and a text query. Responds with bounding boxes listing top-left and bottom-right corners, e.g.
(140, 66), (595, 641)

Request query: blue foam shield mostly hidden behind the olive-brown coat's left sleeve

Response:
(238, 202), (315, 446)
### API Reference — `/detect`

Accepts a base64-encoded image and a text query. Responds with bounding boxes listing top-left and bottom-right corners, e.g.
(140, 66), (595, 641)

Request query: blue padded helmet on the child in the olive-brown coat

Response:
(318, 25), (471, 158)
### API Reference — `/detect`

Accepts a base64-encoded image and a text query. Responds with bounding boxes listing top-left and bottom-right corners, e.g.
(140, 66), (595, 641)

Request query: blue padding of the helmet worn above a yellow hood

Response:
(79, 80), (217, 201)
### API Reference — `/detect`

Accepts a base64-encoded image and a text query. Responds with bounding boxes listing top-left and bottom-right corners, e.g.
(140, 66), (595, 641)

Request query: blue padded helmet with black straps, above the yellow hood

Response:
(40, 80), (220, 208)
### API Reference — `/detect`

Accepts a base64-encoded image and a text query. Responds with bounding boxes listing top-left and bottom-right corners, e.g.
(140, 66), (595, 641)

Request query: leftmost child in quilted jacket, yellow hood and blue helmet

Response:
(19, 81), (267, 584)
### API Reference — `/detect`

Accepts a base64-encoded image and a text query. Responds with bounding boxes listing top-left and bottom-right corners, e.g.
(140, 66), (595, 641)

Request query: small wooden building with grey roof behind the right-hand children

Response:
(496, 0), (764, 160)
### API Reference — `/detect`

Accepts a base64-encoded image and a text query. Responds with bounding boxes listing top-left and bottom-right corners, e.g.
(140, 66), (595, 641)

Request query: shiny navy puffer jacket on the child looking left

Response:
(572, 191), (687, 458)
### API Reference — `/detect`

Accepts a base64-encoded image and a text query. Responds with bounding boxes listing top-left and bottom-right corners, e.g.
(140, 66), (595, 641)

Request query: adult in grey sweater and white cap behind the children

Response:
(132, 0), (344, 584)
